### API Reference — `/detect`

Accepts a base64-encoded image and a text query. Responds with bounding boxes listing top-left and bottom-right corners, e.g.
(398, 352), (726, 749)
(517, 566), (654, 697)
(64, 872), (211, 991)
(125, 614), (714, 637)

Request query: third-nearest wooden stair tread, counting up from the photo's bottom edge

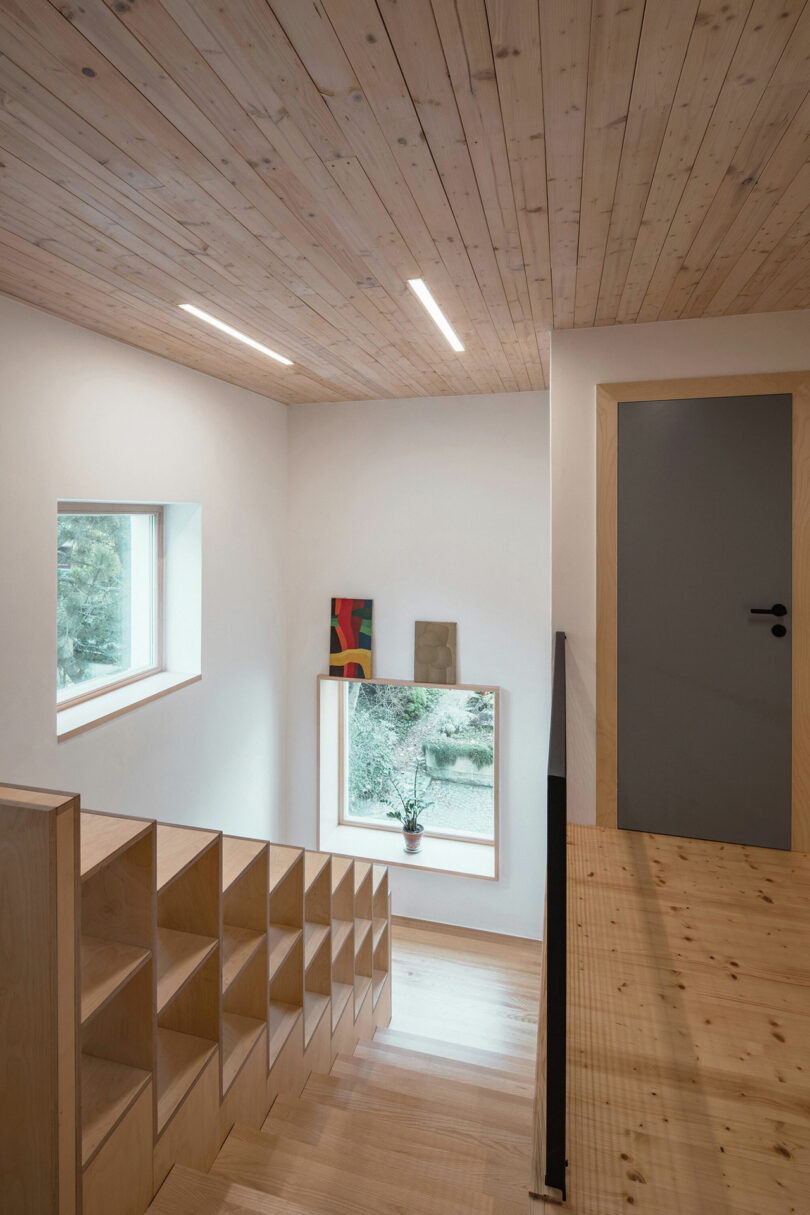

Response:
(262, 1097), (529, 1202)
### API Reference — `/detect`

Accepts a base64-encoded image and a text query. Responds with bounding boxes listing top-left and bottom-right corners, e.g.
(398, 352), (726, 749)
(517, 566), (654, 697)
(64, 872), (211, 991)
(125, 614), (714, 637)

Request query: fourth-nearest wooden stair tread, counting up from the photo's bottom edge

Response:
(304, 1073), (531, 1146)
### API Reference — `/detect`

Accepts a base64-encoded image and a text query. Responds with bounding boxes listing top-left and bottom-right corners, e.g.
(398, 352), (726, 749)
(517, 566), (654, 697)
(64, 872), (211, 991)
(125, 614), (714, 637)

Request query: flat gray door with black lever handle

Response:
(617, 396), (792, 848)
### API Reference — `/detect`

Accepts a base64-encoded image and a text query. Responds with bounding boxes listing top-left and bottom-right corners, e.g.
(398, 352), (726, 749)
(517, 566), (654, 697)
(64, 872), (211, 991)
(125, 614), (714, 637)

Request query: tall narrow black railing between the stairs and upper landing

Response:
(545, 633), (567, 1200)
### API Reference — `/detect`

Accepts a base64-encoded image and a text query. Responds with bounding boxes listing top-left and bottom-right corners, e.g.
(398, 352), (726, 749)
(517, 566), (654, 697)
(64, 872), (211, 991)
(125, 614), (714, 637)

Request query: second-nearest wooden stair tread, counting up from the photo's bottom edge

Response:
(211, 1126), (525, 1215)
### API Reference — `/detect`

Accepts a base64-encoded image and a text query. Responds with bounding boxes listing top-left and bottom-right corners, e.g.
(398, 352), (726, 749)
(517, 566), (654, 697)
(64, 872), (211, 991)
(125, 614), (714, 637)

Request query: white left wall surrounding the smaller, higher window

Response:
(0, 298), (288, 838)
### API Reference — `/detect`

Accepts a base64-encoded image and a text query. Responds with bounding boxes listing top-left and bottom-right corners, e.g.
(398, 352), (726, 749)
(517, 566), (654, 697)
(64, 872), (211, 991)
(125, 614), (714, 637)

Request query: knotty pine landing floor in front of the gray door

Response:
(563, 826), (810, 1215)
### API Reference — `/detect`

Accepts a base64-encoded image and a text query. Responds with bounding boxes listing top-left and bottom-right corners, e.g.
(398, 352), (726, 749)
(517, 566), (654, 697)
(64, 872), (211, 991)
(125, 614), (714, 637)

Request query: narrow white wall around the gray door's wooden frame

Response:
(551, 312), (810, 823)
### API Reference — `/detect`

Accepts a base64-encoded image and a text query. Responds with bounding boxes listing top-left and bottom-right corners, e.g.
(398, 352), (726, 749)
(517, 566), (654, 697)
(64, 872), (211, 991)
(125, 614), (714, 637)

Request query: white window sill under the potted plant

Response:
(318, 824), (498, 882)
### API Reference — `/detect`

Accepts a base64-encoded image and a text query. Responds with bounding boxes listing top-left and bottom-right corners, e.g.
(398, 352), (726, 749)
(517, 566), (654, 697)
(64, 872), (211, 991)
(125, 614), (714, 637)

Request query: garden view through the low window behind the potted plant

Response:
(339, 679), (497, 842)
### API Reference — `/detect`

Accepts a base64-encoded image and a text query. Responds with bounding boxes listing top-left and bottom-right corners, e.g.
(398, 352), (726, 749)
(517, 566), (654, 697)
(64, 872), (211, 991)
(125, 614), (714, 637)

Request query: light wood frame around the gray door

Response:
(596, 372), (810, 852)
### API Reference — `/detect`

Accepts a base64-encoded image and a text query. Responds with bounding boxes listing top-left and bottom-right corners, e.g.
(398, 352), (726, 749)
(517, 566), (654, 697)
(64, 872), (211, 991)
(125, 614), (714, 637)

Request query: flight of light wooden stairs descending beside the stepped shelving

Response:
(149, 1030), (533, 1215)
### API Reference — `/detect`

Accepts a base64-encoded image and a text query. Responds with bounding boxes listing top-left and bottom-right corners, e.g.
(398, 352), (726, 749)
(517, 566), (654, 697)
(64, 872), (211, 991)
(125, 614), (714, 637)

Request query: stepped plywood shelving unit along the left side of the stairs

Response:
(0, 785), (390, 1215)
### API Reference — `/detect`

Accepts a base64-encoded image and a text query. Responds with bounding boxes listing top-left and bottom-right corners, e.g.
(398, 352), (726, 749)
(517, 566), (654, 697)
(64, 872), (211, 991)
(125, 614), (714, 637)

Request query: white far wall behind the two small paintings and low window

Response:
(288, 392), (550, 937)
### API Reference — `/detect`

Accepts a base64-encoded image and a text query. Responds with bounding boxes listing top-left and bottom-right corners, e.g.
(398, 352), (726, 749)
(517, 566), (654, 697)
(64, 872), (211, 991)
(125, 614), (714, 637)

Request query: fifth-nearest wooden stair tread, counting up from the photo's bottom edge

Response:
(332, 1055), (533, 1125)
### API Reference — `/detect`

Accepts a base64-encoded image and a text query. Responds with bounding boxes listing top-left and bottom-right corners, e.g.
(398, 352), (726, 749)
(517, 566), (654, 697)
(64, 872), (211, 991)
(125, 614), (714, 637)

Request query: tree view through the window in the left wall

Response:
(56, 503), (163, 708)
